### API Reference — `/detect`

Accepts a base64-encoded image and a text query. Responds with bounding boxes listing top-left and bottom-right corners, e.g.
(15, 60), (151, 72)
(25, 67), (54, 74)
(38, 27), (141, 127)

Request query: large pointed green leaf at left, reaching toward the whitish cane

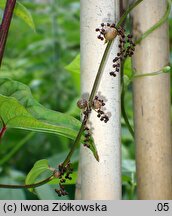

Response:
(0, 78), (81, 139)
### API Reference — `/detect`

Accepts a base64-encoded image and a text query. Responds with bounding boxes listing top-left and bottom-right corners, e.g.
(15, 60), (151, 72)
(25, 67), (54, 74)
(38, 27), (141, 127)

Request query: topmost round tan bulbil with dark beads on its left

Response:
(96, 23), (118, 41)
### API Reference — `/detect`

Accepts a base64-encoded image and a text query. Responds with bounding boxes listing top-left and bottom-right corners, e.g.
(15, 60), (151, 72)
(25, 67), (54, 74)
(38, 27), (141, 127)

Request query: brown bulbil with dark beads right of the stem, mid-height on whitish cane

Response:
(92, 96), (109, 123)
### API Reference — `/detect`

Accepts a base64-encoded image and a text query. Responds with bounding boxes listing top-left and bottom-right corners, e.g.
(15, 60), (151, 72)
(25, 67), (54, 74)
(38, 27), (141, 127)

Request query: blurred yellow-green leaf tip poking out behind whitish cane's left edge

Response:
(65, 54), (80, 94)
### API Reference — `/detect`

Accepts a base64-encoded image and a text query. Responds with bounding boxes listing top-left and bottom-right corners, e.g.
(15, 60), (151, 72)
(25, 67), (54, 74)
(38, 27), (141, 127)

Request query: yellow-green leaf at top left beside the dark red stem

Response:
(0, 0), (35, 31)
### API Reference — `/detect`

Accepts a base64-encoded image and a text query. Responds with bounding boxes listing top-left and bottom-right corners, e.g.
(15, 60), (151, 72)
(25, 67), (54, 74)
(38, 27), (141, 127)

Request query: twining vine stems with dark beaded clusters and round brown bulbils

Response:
(0, 0), (170, 196)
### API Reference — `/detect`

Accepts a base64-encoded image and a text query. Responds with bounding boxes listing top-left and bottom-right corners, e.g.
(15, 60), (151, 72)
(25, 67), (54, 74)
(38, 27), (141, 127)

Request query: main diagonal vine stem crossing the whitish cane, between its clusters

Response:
(62, 0), (143, 166)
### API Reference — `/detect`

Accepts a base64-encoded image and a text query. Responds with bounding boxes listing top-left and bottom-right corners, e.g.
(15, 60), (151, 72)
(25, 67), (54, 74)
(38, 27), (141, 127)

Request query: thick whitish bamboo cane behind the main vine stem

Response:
(80, 0), (121, 200)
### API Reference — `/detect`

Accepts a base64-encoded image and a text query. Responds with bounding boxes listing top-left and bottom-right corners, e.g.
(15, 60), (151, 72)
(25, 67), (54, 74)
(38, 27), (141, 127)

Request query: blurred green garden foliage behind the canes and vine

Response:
(0, 0), (172, 200)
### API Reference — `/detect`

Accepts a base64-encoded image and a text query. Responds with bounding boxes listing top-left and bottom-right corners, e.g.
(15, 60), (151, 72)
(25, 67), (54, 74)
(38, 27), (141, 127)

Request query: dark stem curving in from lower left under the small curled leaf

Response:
(0, 175), (54, 189)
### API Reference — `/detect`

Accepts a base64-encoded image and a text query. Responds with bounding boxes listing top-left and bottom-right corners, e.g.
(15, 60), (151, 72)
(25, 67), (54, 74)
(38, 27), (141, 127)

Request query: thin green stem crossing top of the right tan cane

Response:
(135, 0), (171, 44)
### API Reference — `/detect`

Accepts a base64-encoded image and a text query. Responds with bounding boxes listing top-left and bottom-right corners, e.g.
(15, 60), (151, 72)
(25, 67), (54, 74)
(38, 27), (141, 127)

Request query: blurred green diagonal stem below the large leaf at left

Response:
(0, 132), (35, 165)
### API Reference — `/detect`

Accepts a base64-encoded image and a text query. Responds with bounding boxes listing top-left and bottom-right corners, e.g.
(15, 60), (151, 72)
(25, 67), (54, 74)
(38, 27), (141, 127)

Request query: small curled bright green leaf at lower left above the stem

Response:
(25, 159), (49, 191)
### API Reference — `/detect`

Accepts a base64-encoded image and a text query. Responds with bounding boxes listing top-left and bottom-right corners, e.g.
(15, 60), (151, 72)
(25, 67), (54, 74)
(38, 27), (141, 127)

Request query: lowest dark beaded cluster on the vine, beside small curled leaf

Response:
(54, 162), (73, 196)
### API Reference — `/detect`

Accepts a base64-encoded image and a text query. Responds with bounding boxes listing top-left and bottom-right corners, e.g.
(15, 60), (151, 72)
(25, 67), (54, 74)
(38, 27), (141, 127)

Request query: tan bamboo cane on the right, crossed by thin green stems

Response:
(133, 0), (172, 200)
